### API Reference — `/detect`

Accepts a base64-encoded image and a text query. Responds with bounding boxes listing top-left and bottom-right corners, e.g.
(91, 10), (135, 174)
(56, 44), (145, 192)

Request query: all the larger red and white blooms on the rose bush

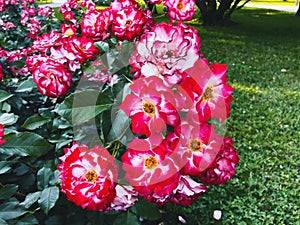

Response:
(0, 0), (239, 212)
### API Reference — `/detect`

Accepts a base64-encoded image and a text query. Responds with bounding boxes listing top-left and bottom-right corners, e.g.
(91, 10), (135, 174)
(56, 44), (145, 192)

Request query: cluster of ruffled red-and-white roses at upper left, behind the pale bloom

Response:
(20, 0), (154, 98)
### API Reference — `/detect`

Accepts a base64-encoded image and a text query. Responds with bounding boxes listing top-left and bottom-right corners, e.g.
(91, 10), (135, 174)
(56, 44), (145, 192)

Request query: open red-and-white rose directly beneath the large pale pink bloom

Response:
(120, 76), (179, 137)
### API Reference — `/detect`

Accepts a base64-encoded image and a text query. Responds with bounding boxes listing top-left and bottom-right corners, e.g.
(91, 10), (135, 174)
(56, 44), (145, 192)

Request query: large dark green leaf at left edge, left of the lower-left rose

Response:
(0, 132), (52, 158)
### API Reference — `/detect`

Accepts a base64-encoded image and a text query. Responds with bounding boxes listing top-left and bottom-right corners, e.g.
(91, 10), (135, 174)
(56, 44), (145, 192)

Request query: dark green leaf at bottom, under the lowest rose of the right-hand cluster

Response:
(135, 198), (161, 220)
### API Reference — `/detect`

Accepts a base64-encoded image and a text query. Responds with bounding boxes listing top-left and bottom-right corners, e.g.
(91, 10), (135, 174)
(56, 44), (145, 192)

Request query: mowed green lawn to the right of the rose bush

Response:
(171, 9), (300, 225)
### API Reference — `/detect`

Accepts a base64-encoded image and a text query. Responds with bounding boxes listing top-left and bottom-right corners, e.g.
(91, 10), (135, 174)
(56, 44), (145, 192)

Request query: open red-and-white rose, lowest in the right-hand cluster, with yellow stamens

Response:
(122, 138), (180, 201)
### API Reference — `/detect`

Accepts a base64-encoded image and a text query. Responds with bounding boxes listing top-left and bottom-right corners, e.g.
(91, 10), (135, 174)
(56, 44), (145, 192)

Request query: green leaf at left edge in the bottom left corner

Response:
(0, 201), (27, 220)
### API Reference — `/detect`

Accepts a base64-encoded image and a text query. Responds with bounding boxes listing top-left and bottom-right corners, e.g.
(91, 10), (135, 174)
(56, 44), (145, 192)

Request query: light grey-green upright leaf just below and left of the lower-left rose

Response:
(38, 186), (59, 214)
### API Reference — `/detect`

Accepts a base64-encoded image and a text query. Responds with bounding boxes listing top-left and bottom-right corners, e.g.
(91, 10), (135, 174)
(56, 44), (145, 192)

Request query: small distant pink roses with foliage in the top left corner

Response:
(0, 0), (60, 76)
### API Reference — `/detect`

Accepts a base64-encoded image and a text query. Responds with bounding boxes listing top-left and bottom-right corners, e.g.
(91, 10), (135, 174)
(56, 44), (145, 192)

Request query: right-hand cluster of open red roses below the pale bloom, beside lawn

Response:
(120, 53), (238, 205)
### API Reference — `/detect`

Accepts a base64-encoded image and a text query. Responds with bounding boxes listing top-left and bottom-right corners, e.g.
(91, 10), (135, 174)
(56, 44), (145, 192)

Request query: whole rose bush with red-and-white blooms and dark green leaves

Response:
(0, 0), (239, 225)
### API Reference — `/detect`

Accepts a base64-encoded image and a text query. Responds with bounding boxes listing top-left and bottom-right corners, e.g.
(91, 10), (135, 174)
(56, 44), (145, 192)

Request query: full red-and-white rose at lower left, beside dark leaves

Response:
(58, 143), (121, 211)
